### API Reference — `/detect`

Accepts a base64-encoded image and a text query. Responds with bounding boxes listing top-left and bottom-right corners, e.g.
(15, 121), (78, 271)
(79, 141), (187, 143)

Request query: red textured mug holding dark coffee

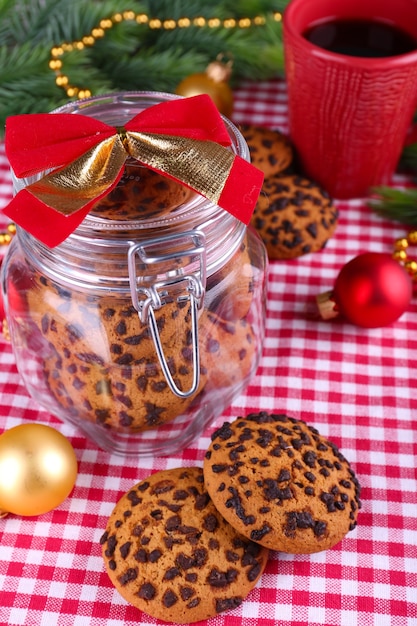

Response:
(283, 0), (417, 198)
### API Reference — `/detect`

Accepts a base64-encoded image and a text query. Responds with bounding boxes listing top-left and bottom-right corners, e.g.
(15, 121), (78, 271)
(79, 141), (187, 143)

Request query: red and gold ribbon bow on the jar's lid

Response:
(4, 95), (263, 247)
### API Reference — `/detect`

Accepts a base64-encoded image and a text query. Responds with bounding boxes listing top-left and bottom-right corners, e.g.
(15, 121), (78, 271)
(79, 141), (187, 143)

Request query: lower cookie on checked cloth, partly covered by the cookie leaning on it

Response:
(101, 467), (268, 624)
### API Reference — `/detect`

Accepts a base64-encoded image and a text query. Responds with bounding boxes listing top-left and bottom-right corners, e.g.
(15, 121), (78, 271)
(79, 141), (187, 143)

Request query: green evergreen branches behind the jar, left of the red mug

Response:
(0, 0), (287, 128)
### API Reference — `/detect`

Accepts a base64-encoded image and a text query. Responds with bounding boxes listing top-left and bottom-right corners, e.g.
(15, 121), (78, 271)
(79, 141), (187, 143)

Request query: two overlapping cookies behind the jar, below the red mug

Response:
(239, 124), (338, 260)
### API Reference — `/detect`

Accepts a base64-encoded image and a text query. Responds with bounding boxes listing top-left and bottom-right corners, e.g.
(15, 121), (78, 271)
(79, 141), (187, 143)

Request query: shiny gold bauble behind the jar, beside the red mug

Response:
(175, 54), (233, 117)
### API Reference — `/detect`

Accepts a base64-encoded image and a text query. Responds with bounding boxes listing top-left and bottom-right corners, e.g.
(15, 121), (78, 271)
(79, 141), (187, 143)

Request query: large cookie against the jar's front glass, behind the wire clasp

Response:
(28, 276), (206, 433)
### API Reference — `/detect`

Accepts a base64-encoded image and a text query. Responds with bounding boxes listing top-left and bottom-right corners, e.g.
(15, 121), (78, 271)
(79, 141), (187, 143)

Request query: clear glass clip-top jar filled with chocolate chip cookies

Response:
(2, 92), (267, 455)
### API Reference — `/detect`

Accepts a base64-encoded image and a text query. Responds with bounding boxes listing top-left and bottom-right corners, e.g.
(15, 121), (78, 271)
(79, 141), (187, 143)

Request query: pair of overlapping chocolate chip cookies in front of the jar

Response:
(101, 412), (361, 624)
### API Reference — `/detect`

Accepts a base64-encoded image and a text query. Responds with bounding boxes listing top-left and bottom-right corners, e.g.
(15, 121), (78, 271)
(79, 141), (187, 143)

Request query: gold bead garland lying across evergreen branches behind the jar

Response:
(49, 11), (282, 100)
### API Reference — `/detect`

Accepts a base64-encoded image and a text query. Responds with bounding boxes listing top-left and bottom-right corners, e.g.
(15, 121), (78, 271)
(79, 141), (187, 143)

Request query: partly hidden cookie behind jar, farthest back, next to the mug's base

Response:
(239, 124), (294, 177)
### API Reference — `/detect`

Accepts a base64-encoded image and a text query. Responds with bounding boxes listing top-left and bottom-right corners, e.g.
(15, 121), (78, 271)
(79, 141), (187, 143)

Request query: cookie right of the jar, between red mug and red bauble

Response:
(251, 175), (338, 259)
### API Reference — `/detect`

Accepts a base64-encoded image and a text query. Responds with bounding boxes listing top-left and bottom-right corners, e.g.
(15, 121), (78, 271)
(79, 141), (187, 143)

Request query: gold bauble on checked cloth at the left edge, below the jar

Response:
(0, 424), (77, 517)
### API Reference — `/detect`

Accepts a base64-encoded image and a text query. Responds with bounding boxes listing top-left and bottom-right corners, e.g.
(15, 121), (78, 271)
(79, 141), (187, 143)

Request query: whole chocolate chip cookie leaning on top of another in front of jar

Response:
(204, 412), (360, 554)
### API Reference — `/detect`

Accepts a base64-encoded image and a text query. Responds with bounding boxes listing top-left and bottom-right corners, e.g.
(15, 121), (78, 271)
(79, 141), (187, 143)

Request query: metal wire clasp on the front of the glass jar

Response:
(128, 230), (206, 398)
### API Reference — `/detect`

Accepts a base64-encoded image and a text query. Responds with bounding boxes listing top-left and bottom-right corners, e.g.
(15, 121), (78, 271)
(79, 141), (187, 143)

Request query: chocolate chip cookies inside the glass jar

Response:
(27, 163), (264, 438)
